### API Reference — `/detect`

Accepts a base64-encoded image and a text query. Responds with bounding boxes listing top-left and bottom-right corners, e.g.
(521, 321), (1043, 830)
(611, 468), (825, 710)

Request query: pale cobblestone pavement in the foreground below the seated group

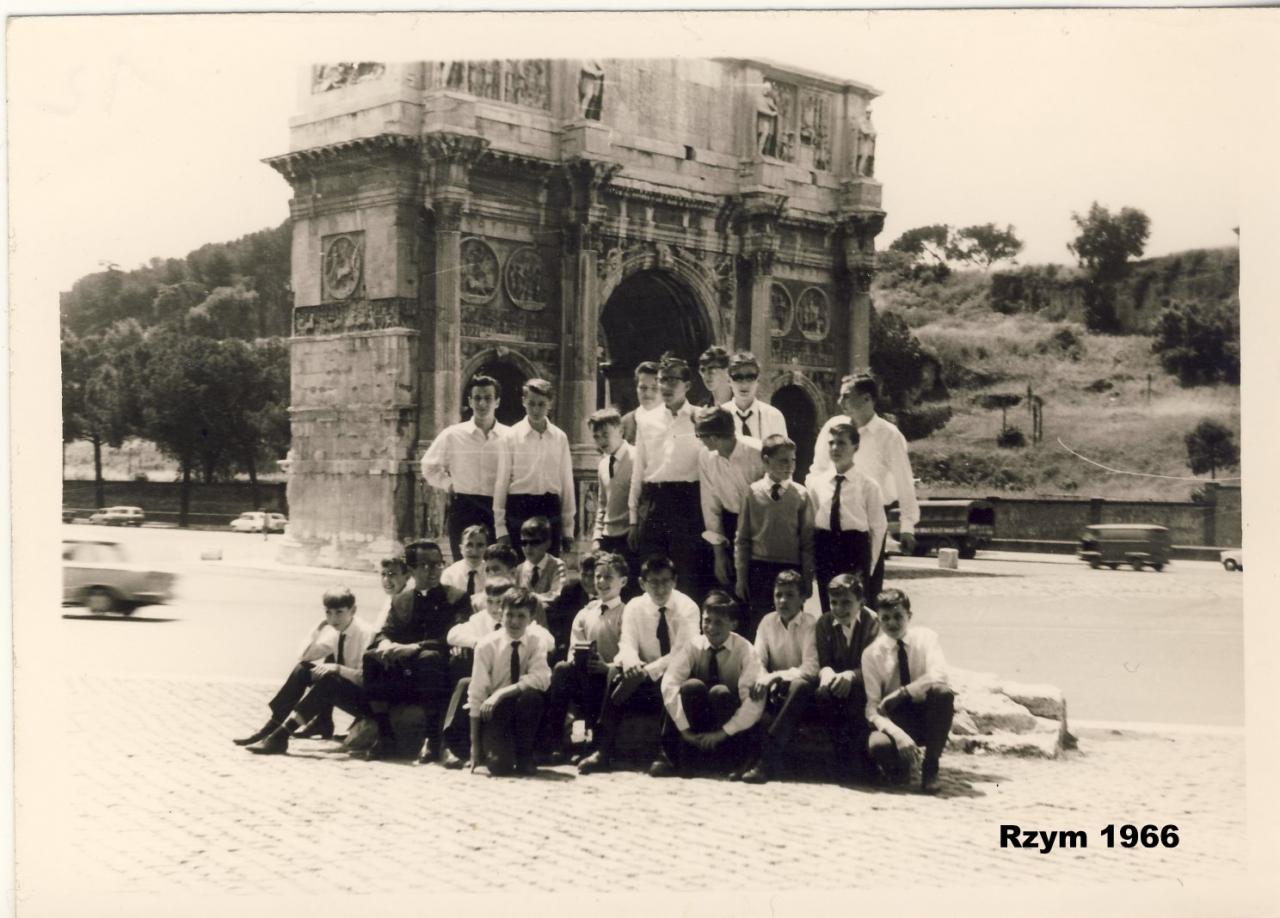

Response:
(30, 675), (1245, 903)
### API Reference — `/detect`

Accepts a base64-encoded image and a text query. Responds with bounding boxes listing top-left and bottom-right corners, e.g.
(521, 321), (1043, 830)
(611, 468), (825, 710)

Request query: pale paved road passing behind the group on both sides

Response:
(57, 525), (1244, 725)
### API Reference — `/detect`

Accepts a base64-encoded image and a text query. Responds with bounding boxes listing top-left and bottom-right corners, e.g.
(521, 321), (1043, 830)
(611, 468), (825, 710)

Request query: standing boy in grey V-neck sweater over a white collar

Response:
(735, 434), (813, 640)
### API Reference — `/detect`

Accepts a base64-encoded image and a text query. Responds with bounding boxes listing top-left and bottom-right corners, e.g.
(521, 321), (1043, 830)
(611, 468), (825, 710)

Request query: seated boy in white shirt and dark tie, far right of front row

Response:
(863, 589), (955, 794)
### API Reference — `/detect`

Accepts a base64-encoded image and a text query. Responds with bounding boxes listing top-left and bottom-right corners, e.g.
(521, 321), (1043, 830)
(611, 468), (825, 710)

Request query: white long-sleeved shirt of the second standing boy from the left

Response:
(493, 417), (577, 539)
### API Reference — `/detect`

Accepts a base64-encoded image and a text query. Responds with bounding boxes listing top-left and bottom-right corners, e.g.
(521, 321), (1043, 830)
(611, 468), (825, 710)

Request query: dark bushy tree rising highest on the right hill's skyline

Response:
(1066, 201), (1151, 332)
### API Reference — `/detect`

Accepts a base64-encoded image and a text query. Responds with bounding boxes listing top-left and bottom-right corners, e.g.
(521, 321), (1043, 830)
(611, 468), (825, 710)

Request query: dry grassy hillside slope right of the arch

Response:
(873, 254), (1240, 499)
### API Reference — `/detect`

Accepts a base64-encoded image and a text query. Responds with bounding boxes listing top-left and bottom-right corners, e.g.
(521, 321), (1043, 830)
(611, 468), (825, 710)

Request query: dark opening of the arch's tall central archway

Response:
(600, 269), (712, 411)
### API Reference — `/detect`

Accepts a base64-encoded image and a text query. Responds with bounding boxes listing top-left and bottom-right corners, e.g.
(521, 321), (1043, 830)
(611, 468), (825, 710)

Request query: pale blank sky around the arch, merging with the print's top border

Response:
(9, 10), (1258, 302)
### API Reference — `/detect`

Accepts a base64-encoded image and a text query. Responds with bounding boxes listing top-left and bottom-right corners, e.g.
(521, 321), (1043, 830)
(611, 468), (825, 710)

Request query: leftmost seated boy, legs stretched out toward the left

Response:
(234, 586), (374, 755)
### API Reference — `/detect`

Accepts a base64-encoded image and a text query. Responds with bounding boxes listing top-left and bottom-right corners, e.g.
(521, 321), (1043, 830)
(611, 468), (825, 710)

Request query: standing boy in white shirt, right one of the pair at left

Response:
(493, 379), (577, 554)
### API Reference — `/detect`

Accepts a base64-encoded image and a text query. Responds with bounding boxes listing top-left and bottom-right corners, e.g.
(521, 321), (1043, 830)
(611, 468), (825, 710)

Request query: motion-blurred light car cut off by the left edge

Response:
(63, 539), (175, 615)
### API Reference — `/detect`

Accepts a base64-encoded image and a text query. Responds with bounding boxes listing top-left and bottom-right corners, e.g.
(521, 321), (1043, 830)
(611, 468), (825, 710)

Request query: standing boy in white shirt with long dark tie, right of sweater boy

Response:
(805, 424), (888, 612)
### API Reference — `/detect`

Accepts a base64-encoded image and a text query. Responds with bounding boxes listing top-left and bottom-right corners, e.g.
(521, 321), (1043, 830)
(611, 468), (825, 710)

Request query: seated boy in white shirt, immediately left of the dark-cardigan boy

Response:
(742, 571), (818, 784)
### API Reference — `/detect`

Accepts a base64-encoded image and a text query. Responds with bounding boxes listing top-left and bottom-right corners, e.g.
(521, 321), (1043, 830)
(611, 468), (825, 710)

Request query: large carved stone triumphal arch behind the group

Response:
(268, 59), (884, 567)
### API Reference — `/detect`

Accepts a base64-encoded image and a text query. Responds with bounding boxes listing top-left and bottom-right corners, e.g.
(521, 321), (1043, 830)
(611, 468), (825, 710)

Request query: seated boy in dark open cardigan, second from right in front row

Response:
(813, 574), (879, 782)
